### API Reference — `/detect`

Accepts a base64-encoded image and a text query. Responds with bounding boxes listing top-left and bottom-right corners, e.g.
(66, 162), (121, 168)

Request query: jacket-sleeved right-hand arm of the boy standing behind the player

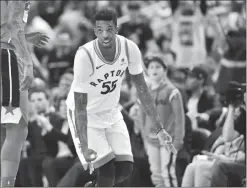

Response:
(169, 88), (185, 150)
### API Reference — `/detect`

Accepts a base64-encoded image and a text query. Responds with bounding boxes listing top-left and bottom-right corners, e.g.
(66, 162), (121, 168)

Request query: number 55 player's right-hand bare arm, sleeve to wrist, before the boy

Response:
(131, 73), (162, 131)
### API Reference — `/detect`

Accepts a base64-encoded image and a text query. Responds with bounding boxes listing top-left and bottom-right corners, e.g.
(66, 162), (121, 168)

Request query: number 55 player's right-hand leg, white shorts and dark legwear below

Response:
(106, 120), (134, 184)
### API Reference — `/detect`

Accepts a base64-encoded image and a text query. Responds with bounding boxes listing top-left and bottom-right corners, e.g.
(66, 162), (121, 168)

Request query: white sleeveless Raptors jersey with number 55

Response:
(67, 35), (129, 114)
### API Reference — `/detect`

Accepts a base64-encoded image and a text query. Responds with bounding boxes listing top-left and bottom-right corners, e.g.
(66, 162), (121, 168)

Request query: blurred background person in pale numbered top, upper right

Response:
(171, 0), (206, 67)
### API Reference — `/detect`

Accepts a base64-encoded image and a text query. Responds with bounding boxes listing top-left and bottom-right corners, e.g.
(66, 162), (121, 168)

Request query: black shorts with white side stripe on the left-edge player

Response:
(1, 49), (20, 107)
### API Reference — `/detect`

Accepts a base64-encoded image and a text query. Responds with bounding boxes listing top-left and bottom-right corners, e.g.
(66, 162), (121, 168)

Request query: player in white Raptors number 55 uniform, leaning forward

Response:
(67, 9), (176, 187)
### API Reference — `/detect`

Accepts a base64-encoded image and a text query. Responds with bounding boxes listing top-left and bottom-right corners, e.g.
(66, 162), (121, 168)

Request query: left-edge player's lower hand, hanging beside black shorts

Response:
(20, 64), (34, 91)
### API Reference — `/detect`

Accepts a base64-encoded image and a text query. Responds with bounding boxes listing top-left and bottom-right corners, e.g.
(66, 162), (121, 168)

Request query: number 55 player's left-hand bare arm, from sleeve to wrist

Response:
(74, 92), (88, 152)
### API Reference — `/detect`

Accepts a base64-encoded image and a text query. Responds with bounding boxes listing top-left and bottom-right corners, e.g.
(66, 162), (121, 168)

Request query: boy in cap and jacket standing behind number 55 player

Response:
(140, 57), (185, 187)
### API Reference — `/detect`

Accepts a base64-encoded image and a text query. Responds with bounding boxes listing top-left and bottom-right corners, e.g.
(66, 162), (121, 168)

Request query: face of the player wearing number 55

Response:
(94, 20), (117, 47)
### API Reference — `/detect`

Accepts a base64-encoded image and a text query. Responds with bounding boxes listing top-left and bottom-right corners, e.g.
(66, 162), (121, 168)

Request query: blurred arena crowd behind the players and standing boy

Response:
(8, 0), (246, 187)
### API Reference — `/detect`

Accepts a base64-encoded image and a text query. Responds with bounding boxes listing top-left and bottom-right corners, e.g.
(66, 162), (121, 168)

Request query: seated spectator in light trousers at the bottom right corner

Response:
(182, 101), (246, 187)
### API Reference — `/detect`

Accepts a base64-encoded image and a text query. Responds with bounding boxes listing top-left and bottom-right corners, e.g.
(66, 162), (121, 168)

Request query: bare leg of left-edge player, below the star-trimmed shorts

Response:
(1, 118), (28, 187)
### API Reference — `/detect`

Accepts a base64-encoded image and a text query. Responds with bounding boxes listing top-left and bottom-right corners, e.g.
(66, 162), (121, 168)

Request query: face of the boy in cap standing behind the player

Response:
(148, 61), (166, 81)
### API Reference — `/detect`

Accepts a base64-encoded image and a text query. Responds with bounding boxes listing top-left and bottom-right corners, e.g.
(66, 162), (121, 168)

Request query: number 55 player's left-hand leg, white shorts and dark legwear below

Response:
(67, 109), (115, 187)
